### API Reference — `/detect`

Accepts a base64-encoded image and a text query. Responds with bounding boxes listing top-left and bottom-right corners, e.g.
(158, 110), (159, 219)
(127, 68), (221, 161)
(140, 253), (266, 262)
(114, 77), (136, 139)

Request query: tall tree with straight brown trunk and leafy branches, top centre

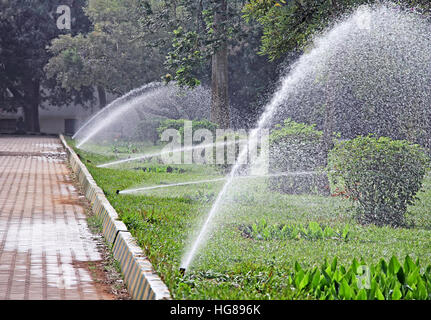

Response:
(154, 0), (250, 128)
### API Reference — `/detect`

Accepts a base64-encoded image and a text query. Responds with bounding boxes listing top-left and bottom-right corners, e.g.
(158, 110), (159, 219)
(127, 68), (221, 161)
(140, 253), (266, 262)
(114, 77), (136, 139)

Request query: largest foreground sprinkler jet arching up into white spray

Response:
(181, 5), (431, 269)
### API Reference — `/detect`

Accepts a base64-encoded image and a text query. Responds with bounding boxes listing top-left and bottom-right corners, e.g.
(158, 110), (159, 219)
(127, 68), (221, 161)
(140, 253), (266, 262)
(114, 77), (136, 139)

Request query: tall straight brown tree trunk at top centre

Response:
(211, 0), (230, 128)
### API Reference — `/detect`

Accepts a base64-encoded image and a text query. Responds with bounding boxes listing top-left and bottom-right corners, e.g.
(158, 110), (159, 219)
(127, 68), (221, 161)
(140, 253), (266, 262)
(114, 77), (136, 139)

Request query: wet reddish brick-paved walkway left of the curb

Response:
(0, 136), (110, 300)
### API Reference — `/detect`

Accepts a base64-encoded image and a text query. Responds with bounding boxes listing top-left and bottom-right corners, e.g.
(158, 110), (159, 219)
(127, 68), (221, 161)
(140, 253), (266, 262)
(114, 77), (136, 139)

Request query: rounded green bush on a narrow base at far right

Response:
(328, 135), (428, 226)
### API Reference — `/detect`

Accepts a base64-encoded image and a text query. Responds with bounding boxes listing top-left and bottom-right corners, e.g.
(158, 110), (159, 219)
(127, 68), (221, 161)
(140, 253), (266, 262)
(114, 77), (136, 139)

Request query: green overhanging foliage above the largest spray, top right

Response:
(244, 0), (431, 60)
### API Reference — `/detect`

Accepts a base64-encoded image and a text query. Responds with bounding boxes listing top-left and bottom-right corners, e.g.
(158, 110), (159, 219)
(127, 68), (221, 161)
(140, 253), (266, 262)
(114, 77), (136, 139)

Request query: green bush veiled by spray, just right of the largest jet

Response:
(269, 119), (329, 194)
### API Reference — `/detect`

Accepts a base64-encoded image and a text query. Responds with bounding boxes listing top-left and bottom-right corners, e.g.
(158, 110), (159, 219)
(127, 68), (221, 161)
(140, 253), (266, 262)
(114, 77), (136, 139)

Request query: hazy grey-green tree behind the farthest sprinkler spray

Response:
(45, 0), (163, 107)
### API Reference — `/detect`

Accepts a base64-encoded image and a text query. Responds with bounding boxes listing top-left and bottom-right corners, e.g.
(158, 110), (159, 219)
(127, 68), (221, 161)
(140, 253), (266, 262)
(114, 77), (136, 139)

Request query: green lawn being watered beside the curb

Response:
(68, 138), (431, 299)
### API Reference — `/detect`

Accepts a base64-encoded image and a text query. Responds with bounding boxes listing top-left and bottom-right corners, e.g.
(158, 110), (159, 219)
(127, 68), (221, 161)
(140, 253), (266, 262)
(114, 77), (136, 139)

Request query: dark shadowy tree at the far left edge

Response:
(0, 0), (92, 132)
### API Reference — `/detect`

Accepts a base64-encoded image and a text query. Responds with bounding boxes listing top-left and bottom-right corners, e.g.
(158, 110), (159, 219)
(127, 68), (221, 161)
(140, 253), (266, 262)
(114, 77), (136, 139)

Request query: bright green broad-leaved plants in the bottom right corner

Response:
(289, 256), (431, 300)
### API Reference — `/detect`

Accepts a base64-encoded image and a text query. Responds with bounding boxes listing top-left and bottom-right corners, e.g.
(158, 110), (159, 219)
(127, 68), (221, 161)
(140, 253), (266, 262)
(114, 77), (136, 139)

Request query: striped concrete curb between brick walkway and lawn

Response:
(60, 135), (171, 300)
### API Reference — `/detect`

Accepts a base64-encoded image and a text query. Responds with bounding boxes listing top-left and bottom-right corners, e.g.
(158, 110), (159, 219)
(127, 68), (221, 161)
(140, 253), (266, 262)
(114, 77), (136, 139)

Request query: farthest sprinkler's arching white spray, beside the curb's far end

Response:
(73, 82), (210, 148)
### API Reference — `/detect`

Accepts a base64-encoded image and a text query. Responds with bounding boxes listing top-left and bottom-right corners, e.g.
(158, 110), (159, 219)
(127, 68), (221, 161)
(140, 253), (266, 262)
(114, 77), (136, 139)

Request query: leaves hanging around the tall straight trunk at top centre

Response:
(159, 0), (246, 87)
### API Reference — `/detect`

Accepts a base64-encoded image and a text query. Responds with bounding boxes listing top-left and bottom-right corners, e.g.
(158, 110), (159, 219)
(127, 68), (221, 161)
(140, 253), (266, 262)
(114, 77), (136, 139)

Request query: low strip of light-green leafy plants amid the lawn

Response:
(241, 218), (350, 241)
